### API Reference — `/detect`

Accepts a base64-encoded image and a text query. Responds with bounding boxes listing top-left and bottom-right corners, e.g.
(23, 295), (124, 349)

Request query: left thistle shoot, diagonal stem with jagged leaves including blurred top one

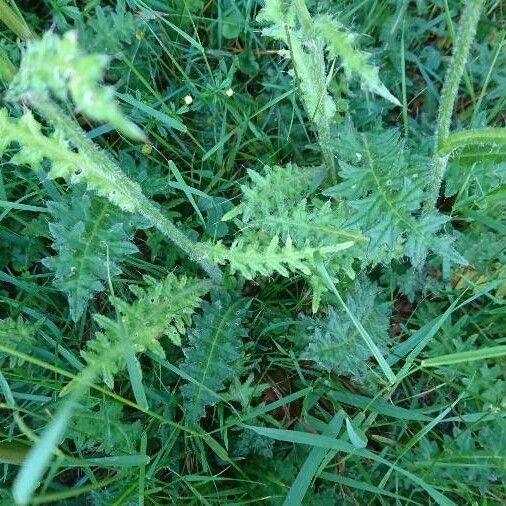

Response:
(0, 32), (221, 282)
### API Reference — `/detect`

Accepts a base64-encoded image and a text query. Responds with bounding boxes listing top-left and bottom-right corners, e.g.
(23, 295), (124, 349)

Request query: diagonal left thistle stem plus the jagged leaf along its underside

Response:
(0, 105), (222, 282)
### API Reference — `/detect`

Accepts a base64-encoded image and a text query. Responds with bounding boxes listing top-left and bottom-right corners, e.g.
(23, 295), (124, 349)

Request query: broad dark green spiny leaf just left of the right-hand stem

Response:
(325, 125), (467, 266)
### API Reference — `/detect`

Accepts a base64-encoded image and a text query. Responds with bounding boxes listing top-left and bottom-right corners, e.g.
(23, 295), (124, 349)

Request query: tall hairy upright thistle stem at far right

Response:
(425, 0), (484, 212)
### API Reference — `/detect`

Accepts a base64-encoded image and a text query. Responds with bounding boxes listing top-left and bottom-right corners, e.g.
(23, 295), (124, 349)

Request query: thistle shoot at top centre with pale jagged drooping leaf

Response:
(257, 0), (399, 180)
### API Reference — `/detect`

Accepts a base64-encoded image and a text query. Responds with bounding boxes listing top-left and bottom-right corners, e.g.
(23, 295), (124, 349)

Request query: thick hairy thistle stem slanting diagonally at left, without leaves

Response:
(31, 97), (223, 283)
